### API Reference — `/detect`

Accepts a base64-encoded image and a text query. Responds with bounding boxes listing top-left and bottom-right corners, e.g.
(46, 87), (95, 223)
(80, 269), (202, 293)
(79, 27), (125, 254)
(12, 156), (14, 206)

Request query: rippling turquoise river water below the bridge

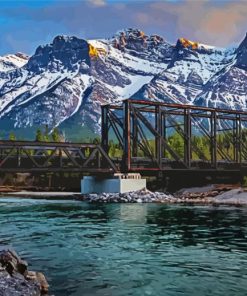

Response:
(0, 198), (247, 296)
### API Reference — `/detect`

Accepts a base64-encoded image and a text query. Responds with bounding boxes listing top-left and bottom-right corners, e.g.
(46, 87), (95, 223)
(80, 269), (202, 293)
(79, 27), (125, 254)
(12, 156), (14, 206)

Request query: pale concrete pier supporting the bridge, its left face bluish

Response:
(81, 174), (146, 194)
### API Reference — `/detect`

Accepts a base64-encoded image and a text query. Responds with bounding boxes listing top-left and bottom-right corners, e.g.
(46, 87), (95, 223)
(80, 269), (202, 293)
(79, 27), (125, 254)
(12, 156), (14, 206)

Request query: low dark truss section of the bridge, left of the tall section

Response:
(0, 141), (118, 173)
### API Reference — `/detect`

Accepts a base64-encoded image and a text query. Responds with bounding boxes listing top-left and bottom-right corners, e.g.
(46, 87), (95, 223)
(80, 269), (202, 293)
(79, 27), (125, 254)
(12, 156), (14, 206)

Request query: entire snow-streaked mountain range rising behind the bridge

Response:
(0, 29), (247, 141)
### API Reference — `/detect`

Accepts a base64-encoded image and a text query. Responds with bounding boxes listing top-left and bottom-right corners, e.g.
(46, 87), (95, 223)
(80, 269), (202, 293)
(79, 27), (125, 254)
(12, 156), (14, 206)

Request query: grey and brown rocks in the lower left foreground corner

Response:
(0, 250), (49, 296)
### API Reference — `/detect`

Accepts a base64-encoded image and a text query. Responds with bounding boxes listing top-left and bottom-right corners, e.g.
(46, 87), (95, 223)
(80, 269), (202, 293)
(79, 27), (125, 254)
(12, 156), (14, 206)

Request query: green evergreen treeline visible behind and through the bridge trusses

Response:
(6, 126), (247, 160)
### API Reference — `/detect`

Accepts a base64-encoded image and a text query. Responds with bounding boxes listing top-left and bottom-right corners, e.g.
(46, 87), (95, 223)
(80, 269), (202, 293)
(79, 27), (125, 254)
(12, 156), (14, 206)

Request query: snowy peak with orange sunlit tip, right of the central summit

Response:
(134, 38), (235, 106)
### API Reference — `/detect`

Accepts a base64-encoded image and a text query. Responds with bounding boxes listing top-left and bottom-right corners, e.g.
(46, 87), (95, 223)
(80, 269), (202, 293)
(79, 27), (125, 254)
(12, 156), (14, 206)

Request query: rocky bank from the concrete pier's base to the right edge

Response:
(79, 185), (247, 204)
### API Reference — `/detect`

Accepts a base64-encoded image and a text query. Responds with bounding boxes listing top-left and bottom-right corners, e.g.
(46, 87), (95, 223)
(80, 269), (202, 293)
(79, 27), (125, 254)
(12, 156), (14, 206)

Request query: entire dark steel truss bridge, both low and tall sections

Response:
(0, 100), (247, 174)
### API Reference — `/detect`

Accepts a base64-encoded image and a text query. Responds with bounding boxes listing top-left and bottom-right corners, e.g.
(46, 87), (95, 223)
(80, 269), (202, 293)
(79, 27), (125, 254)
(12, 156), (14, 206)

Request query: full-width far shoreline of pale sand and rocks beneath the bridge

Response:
(0, 184), (247, 205)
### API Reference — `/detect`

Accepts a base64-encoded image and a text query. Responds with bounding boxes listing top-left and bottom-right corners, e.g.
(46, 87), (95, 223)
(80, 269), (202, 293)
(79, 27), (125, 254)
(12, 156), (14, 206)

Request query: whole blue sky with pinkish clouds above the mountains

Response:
(0, 0), (247, 55)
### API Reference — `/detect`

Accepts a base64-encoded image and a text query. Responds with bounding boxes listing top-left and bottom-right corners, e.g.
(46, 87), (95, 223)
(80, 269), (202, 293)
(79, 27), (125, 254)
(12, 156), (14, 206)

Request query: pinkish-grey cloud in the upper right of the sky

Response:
(150, 0), (247, 46)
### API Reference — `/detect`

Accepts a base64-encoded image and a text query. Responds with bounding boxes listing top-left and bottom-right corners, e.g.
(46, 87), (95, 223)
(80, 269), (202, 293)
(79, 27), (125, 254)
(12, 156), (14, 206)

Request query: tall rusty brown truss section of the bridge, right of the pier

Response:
(102, 100), (247, 172)
